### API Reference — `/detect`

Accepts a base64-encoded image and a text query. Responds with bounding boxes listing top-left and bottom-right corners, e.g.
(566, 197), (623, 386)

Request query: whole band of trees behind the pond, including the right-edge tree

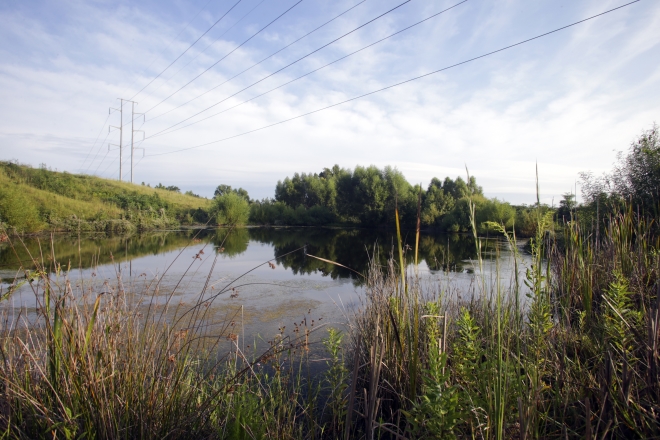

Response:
(209, 124), (660, 236)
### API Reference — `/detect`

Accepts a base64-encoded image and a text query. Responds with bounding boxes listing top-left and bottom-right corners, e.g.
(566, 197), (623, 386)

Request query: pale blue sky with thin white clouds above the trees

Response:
(0, 0), (660, 205)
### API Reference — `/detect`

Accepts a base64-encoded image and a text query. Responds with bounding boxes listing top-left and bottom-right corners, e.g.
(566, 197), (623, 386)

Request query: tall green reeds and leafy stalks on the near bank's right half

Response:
(342, 180), (660, 439)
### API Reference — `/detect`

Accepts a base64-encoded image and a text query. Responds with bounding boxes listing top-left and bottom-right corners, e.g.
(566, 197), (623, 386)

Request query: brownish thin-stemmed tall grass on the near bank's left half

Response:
(0, 230), (346, 439)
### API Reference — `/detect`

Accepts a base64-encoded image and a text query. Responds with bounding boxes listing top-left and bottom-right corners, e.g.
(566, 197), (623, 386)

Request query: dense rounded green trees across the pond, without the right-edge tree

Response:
(211, 165), (532, 233)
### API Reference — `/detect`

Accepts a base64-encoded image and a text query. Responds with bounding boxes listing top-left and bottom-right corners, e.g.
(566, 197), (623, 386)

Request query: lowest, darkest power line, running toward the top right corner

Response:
(150, 0), (641, 156)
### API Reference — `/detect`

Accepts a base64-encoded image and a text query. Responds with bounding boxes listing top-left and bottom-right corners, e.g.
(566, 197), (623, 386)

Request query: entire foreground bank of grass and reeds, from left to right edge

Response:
(0, 181), (660, 440)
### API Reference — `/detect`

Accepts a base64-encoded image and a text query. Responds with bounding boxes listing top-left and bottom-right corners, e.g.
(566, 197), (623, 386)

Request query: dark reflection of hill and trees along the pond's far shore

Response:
(0, 228), (494, 283)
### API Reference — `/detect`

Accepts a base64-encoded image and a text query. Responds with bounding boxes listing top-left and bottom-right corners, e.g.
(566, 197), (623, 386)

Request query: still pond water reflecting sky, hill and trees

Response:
(0, 228), (524, 343)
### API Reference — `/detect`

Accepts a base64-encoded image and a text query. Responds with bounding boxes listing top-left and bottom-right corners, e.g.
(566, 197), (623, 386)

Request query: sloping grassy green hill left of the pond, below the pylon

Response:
(0, 162), (211, 232)
